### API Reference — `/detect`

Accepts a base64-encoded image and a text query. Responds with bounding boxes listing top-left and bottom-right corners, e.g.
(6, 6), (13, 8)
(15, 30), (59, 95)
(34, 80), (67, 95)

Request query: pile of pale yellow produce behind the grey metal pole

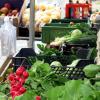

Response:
(22, 4), (61, 32)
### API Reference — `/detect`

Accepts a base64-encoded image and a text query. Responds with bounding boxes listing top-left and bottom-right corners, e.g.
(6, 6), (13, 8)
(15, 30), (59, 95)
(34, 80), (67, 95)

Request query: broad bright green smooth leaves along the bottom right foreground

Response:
(46, 80), (96, 100)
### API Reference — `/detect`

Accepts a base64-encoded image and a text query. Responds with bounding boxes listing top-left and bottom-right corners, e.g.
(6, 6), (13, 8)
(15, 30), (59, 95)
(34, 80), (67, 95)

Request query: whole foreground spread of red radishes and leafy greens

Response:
(0, 60), (100, 100)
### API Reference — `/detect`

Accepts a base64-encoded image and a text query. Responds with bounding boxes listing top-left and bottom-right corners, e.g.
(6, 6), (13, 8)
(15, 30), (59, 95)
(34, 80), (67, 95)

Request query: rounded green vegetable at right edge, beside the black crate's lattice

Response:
(83, 64), (100, 78)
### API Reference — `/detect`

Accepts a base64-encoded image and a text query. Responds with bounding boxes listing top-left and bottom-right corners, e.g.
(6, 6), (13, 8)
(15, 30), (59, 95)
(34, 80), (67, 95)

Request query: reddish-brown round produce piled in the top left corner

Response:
(0, 3), (18, 16)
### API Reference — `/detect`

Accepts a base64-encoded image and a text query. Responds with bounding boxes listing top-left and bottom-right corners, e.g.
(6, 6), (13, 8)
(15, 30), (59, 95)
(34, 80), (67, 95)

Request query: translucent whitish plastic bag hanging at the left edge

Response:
(0, 17), (16, 56)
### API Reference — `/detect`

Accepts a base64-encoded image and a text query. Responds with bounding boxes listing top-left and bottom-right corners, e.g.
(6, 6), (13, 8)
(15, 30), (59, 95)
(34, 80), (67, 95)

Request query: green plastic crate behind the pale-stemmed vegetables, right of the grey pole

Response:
(42, 24), (76, 44)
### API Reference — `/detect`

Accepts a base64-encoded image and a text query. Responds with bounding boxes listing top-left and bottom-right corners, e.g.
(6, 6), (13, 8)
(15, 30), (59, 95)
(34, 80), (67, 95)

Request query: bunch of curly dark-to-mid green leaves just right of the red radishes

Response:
(25, 61), (67, 95)
